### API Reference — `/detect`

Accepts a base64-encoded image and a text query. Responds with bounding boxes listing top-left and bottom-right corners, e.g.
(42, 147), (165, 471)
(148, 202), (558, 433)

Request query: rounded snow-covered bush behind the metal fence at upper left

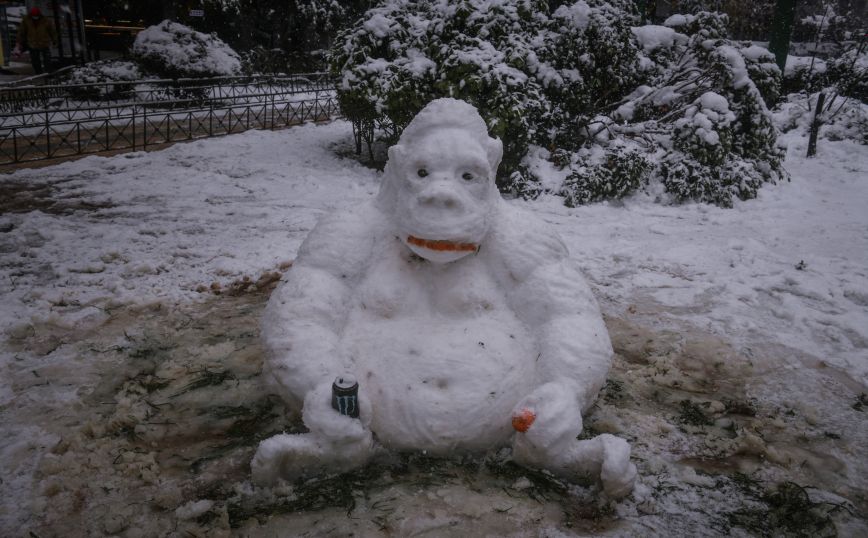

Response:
(132, 20), (241, 78)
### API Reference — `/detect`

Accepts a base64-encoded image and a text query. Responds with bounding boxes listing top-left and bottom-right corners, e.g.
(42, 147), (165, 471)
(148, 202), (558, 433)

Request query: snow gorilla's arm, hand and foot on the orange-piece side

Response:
(497, 206), (636, 498)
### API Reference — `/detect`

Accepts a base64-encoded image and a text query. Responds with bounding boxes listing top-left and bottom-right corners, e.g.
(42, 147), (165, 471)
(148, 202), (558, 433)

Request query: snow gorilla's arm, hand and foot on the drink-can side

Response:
(250, 204), (381, 485)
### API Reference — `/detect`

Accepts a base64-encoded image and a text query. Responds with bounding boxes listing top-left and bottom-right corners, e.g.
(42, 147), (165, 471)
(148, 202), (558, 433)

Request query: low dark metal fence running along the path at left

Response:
(0, 73), (339, 164)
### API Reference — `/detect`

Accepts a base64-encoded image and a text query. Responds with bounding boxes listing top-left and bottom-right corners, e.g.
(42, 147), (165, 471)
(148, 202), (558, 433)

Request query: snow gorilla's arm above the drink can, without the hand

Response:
(262, 205), (379, 403)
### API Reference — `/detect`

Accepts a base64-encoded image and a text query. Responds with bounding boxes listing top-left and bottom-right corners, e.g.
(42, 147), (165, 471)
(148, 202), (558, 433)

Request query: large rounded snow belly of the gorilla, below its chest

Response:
(342, 309), (537, 454)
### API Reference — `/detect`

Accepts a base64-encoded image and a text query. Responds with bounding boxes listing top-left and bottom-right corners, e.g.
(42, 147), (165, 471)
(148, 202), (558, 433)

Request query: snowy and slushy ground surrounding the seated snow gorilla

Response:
(0, 122), (868, 537)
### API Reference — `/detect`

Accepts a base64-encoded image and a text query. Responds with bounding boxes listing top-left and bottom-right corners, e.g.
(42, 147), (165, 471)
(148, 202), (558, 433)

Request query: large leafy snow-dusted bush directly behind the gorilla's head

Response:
(332, 0), (638, 180)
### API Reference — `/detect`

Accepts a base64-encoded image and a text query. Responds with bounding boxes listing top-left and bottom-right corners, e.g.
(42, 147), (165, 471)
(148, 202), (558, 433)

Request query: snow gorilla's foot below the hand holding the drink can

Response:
(250, 433), (373, 486)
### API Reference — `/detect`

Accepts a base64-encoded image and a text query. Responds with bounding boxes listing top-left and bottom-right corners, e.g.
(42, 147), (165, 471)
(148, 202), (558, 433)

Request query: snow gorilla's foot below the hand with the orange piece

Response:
(513, 429), (637, 499)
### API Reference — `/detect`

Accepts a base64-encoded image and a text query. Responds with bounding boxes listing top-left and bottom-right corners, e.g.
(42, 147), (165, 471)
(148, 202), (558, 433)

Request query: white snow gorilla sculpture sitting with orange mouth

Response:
(251, 99), (636, 497)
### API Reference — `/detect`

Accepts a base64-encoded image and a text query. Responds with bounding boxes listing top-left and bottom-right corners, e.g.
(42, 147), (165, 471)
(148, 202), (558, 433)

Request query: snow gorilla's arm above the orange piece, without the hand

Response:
(495, 206), (612, 410)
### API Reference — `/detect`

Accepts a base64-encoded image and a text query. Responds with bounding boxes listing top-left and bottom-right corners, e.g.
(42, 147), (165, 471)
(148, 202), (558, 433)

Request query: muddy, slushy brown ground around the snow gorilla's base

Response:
(2, 292), (868, 537)
